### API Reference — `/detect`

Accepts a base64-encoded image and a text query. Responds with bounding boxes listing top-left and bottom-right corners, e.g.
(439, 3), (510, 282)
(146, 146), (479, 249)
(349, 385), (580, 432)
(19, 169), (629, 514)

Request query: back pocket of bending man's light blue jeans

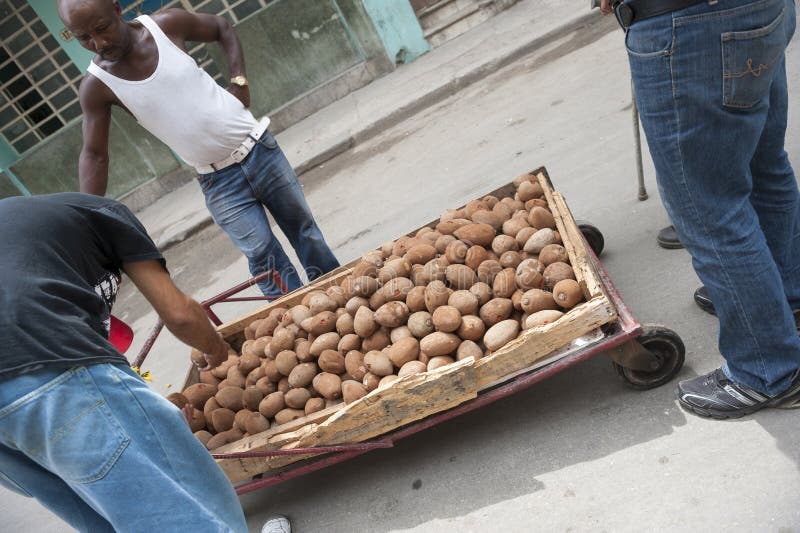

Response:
(0, 367), (130, 483)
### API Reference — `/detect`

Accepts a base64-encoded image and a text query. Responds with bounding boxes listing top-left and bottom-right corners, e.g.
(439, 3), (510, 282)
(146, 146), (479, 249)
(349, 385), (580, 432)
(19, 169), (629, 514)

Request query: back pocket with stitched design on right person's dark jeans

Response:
(721, 8), (787, 109)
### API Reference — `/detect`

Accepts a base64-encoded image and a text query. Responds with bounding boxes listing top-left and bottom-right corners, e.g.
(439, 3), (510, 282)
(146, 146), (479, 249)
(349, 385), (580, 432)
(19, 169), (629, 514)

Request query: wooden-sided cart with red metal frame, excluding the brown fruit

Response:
(137, 168), (684, 494)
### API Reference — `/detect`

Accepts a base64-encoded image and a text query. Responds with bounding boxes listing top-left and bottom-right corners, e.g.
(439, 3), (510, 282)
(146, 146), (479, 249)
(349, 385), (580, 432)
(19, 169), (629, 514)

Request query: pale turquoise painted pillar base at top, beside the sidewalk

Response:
(363, 0), (430, 63)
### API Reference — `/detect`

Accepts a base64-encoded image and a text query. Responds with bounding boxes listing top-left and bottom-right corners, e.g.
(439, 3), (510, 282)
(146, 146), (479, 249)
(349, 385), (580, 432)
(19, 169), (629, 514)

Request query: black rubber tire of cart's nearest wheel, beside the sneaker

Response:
(611, 324), (686, 390)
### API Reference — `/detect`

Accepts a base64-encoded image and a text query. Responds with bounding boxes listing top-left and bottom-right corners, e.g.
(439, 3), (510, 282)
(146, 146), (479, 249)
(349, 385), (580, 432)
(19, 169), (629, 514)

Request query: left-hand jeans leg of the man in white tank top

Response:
(200, 164), (303, 295)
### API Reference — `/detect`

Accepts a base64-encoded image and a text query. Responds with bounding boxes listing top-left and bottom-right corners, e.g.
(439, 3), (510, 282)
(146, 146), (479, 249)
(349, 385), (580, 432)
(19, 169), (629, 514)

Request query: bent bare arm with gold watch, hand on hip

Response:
(154, 9), (250, 107)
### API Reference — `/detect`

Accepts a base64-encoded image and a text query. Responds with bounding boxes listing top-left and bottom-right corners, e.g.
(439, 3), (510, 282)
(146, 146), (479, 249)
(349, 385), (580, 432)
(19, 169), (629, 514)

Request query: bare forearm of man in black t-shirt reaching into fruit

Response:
(122, 260), (229, 370)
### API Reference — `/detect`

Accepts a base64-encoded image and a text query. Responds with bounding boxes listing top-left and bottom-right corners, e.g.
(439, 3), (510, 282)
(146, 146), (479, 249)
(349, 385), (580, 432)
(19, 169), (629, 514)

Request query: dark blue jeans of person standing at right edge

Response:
(626, 0), (800, 395)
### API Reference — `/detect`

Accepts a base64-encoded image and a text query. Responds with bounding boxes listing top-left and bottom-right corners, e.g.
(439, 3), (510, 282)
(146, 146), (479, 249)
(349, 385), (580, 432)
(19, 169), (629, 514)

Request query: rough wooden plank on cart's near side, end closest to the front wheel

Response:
(475, 297), (617, 390)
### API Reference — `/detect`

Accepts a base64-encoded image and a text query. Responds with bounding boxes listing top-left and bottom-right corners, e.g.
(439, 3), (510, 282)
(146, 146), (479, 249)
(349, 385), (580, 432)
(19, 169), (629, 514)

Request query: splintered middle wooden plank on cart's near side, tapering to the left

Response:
(297, 357), (478, 448)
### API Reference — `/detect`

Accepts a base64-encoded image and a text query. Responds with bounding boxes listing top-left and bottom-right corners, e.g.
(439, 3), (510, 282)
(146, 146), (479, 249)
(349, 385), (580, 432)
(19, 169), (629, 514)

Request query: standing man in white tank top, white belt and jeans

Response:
(58, 0), (339, 295)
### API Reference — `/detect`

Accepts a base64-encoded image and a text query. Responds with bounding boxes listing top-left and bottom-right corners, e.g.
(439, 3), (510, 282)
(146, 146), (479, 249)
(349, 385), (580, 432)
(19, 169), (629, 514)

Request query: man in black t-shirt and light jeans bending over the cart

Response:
(0, 193), (247, 531)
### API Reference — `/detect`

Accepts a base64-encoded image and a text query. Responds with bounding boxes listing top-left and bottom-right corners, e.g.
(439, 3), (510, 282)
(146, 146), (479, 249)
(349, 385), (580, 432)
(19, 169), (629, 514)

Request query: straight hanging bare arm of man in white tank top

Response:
(78, 75), (111, 196)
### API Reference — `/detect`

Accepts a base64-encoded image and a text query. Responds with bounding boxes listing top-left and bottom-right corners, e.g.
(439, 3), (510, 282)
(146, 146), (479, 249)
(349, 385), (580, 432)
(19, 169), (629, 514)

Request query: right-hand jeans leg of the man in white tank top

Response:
(238, 131), (339, 281)
